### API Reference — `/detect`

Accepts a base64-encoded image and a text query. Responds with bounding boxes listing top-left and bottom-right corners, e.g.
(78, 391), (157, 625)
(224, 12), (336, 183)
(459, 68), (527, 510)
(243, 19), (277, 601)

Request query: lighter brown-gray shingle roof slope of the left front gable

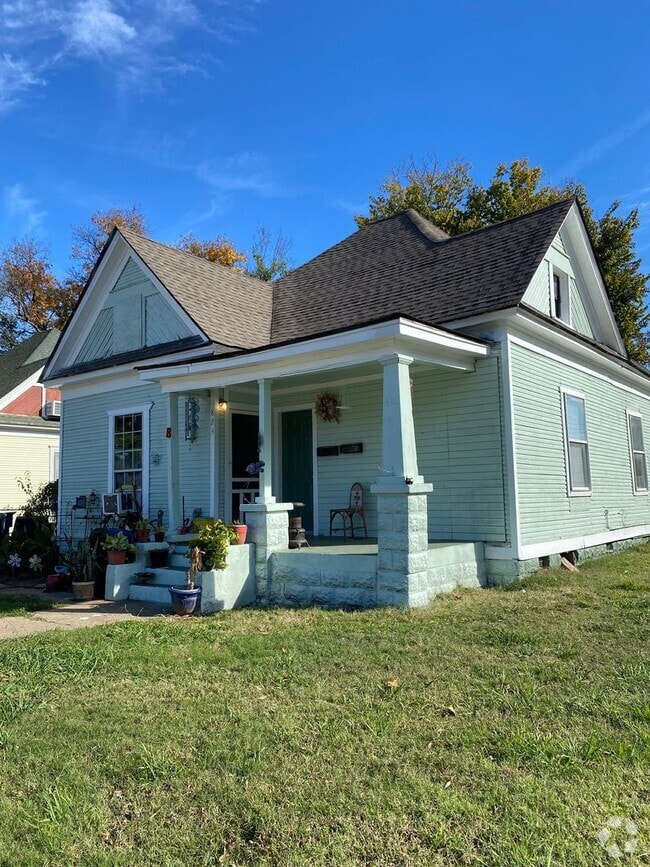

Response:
(118, 229), (273, 349)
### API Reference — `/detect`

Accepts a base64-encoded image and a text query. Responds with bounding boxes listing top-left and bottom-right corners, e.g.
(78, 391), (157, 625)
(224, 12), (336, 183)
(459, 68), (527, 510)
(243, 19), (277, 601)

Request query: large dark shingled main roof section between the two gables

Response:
(271, 199), (575, 343)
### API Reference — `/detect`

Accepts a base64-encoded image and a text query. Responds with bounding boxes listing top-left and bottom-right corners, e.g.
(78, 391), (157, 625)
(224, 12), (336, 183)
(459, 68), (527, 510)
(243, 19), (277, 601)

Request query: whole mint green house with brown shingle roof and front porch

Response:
(44, 200), (650, 605)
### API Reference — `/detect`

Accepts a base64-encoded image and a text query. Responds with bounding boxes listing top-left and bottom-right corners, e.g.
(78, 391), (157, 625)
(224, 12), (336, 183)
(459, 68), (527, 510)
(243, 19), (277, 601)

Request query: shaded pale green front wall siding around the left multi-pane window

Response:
(60, 385), (167, 536)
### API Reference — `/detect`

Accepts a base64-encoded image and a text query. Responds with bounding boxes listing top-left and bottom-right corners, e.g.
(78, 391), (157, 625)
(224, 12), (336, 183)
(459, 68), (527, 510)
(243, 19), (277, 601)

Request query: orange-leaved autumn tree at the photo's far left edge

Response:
(0, 238), (65, 351)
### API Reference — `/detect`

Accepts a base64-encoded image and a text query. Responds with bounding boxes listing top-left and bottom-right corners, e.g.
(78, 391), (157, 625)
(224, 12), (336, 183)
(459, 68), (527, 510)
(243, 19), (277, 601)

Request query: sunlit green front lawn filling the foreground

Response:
(0, 549), (650, 867)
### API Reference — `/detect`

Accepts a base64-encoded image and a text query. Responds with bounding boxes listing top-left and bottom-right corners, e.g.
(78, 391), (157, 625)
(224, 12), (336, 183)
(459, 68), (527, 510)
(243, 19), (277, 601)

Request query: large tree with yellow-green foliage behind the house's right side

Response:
(355, 157), (650, 364)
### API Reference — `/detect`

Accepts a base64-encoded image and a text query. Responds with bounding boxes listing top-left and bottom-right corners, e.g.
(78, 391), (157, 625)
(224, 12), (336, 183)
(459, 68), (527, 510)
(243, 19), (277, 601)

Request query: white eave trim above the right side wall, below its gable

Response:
(509, 310), (650, 399)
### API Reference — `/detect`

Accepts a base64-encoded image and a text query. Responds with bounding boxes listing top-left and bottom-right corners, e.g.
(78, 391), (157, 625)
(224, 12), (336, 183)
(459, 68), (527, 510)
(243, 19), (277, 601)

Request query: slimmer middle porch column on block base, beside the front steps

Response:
(241, 379), (293, 603)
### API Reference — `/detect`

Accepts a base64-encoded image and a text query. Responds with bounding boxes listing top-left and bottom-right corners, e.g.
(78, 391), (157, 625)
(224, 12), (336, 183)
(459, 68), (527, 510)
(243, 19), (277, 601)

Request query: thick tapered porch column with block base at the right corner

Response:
(370, 354), (433, 606)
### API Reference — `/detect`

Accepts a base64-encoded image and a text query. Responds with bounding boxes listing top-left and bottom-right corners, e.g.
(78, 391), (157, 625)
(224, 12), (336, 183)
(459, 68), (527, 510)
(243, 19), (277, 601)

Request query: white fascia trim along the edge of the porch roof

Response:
(140, 319), (490, 391)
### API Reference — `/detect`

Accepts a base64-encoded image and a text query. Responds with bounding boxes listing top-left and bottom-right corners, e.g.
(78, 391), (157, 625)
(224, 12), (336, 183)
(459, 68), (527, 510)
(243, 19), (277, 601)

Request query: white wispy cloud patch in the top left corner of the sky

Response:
(0, 0), (262, 112)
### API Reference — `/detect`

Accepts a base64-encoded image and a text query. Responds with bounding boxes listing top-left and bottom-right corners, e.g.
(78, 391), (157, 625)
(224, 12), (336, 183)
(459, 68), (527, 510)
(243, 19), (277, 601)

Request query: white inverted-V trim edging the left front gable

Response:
(46, 232), (209, 376)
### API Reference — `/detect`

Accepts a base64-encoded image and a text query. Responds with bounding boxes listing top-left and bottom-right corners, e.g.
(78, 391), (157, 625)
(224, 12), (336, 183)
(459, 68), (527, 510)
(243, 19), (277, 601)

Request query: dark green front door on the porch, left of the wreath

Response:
(282, 409), (314, 533)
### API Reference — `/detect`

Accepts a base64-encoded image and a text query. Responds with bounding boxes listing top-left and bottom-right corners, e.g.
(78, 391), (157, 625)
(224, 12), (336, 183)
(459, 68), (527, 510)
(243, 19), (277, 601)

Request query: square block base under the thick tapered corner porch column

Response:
(370, 480), (433, 608)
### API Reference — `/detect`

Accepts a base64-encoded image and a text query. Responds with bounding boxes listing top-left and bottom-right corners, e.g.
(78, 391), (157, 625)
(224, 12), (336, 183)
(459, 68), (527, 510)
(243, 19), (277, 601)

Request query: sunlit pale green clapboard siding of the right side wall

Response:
(512, 345), (650, 545)
